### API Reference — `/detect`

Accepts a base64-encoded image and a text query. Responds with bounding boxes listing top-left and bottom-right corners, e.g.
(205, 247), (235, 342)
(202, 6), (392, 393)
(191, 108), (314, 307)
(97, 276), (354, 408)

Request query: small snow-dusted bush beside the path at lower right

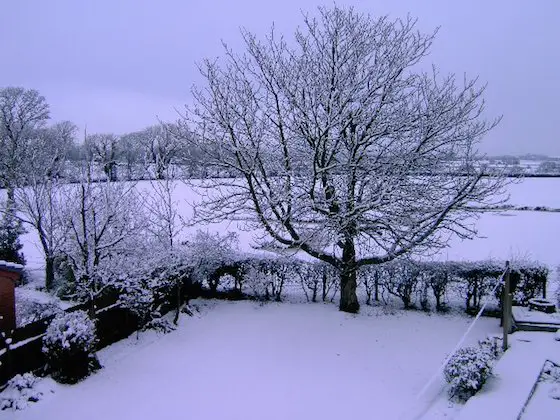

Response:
(444, 345), (495, 400)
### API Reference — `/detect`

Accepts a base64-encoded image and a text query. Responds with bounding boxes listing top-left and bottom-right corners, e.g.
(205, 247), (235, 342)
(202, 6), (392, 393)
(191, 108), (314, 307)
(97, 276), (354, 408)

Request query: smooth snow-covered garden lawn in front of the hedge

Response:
(0, 300), (499, 420)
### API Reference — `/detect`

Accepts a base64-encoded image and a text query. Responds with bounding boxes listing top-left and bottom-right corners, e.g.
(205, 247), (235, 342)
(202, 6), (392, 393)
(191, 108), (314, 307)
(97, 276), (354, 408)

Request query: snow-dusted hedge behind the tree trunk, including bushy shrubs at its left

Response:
(50, 225), (560, 316)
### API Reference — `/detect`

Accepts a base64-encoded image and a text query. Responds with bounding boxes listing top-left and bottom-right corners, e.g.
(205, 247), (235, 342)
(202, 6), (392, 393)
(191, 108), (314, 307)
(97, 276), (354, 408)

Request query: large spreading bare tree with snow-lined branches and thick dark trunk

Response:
(184, 7), (504, 312)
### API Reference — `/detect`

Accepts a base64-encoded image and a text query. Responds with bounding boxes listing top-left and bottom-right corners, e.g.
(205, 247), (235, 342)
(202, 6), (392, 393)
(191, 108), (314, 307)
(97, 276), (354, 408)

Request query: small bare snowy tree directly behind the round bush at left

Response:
(61, 164), (146, 311)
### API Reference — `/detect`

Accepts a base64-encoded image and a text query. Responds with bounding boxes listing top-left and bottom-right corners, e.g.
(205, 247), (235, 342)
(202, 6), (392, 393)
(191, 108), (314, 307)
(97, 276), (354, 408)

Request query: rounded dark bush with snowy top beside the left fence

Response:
(43, 311), (99, 383)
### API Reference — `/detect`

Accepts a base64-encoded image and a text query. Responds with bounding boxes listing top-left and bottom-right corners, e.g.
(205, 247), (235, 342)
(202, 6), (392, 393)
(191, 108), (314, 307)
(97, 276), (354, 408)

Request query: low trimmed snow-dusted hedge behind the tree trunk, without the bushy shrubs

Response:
(187, 257), (549, 312)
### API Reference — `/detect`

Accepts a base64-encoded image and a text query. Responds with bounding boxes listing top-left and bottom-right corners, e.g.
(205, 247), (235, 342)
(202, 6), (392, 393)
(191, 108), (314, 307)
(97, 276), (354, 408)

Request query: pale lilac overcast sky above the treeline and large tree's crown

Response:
(0, 0), (560, 156)
